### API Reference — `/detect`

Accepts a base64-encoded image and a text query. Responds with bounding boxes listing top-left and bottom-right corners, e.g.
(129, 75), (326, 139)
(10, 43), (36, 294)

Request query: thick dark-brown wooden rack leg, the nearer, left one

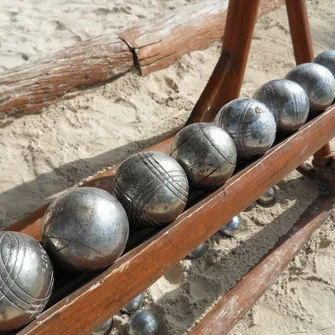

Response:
(186, 0), (260, 124)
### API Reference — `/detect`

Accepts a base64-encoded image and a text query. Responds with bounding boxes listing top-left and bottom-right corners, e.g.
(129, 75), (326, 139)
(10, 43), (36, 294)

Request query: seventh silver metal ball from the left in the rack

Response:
(285, 63), (335, 111)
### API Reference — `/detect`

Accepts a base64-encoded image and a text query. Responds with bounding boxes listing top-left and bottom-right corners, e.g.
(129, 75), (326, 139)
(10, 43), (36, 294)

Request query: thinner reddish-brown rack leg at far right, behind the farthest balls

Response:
(286, 0), (331, 166)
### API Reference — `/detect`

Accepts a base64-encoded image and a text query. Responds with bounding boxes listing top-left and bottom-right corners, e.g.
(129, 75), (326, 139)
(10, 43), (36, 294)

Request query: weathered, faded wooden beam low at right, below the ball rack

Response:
(188, 194), (335, 335)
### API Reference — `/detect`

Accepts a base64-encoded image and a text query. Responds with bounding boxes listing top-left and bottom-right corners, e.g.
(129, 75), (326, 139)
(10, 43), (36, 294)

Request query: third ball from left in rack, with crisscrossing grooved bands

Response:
(114, 151), (189, 227)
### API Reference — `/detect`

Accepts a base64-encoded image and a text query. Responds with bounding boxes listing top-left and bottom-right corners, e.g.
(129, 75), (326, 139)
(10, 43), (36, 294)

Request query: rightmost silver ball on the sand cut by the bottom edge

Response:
(128, 309), (160, 335)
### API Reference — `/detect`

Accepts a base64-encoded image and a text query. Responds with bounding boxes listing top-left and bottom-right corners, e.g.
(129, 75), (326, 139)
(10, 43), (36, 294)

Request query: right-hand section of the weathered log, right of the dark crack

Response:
(119, 0), (284, 75)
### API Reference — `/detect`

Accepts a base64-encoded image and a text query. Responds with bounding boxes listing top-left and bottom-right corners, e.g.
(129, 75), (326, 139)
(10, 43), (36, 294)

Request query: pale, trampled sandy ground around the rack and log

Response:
(0, 0), (335, 335)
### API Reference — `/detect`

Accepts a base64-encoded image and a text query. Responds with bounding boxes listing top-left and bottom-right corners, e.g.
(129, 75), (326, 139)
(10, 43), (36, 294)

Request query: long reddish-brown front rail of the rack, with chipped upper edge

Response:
(13, 106), (335, 335)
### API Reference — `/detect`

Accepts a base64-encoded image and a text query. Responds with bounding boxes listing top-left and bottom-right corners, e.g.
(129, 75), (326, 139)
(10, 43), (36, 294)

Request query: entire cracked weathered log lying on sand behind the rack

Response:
(0, 0), (284, 120)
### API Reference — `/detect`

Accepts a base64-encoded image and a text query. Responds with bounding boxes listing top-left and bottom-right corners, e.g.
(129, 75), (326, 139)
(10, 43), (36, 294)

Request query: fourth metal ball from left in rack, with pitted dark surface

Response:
(170, 122), (237, 188)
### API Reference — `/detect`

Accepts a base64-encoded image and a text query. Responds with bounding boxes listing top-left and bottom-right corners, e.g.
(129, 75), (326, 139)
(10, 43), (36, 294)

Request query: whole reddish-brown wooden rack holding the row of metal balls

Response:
(2, 0), (335, 335)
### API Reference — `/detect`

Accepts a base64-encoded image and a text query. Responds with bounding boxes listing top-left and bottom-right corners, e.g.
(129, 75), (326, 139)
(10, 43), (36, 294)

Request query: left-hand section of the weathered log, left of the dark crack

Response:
(0, 34), (133, 119)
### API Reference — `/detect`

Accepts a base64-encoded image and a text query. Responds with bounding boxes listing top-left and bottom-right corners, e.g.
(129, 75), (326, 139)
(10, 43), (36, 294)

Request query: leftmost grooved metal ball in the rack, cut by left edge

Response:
(0, 232), (54, 333)
